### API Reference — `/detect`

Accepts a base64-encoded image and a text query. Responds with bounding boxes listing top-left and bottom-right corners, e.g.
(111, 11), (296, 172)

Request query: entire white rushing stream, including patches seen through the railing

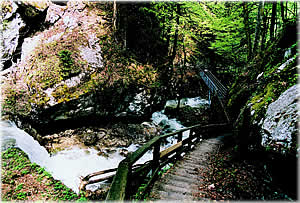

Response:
(0, 97), (206, 193)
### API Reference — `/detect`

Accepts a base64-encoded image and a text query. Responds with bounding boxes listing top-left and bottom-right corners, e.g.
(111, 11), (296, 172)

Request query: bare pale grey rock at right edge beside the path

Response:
(261, 85), (300, 152)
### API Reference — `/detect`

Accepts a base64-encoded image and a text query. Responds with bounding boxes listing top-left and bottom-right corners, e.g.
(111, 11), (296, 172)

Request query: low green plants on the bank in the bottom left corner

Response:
(1, 148), (80, 201)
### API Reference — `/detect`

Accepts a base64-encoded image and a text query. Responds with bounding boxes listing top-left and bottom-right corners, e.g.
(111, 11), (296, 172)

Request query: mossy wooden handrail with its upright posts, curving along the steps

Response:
(106, 123), (230, 201)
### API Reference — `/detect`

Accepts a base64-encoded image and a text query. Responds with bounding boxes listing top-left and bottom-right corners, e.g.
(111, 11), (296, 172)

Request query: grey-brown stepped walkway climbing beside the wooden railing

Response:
(149, 136), (224, 201)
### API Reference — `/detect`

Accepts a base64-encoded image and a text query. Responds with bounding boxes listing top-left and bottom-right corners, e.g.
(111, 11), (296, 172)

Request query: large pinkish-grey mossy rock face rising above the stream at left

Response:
(0, 1), (157, 126)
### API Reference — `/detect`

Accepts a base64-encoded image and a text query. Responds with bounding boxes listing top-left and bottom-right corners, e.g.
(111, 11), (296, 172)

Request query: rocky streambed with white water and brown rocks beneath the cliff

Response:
(1, 98), (210, 195)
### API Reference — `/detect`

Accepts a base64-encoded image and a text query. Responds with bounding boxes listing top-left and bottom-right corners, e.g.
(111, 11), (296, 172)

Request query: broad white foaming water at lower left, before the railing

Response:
(0, 121), (131, 193)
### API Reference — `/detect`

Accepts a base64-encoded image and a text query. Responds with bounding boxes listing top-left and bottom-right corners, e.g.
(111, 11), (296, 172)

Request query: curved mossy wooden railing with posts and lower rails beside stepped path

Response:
(106, 123), (230, 201)
